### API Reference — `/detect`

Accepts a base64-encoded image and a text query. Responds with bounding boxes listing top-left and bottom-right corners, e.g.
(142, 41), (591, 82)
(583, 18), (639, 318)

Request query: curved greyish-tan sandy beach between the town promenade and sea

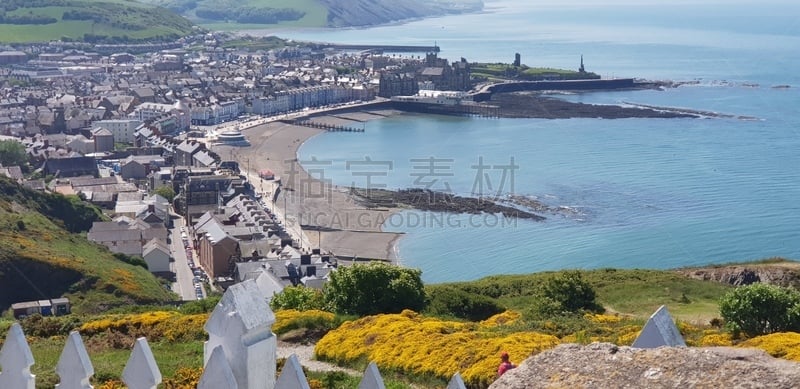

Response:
(213, 110), (402, 262)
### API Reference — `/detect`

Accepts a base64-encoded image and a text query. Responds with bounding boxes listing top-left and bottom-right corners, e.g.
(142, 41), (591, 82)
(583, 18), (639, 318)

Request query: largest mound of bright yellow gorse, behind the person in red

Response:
(315, 310), (559, 387)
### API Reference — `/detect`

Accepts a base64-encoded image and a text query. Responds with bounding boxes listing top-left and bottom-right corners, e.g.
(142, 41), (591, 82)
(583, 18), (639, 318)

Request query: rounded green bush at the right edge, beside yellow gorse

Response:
(719, 283), (800, 336)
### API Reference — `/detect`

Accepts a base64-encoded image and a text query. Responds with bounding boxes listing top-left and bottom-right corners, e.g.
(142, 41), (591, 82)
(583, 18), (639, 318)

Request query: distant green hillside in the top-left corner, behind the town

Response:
(0, 0), (197, 43)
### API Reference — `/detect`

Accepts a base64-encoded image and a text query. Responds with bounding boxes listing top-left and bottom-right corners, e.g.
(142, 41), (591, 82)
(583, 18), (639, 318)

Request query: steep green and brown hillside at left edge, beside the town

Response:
(0, 177), (175, 312)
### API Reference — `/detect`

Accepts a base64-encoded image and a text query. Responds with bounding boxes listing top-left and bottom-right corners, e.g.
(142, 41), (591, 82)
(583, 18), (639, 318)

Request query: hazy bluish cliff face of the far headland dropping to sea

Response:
(321, 0), (483, 27)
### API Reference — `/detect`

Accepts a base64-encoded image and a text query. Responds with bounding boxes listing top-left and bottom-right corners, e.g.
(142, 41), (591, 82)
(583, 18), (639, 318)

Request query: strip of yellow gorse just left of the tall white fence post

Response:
(80, 311), (208, 341)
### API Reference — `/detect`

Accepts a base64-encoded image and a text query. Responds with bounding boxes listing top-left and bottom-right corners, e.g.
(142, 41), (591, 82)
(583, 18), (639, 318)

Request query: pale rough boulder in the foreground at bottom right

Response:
(489, 343), (800, 389)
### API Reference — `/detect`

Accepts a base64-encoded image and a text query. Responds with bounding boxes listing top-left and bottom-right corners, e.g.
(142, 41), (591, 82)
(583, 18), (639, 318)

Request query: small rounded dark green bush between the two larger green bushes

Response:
(543, 270), (603, 312)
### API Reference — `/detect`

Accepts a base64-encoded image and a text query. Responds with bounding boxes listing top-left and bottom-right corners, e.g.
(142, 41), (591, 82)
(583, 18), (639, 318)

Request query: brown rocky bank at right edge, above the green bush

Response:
(675, 259), (800, 288)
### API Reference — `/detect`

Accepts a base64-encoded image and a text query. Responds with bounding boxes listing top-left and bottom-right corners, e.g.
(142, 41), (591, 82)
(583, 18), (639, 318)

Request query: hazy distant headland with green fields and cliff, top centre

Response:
(140, 0), (483, 29)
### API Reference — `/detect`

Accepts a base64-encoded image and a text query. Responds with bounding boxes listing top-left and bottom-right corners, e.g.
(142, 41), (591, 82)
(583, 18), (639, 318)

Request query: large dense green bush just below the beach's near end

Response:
(324, 262), (426, 316)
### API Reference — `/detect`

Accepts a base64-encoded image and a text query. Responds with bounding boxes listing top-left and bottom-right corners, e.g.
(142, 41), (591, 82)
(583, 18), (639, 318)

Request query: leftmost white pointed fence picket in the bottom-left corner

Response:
(0, 323), (36, 389)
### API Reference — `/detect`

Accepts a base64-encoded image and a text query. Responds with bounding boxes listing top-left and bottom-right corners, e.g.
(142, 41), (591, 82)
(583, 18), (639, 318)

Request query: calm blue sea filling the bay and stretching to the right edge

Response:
(264, 0), (800, 283)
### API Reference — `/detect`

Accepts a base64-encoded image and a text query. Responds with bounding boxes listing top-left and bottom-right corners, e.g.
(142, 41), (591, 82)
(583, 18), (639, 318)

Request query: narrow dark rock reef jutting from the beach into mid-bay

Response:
(350, 188), (545, 221)
